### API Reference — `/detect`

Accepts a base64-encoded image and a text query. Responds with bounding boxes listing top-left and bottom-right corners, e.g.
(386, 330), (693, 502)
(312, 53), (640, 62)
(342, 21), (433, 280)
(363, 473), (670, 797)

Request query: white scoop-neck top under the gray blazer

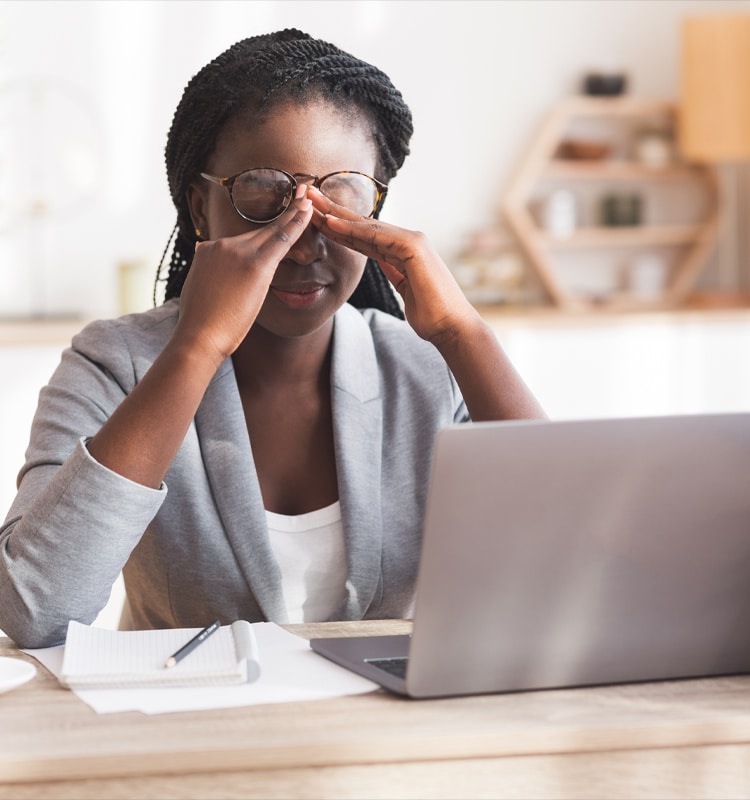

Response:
(266, 501), (346, 622)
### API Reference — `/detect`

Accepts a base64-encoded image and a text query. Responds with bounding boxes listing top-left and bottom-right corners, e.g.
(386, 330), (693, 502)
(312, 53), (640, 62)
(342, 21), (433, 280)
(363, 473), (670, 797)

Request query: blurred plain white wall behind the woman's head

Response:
(0, 0), (750, 316)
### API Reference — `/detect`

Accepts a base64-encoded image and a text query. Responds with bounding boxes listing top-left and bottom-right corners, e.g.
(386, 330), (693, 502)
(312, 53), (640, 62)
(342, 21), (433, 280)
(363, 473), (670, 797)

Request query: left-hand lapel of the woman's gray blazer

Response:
(195, 358), (286, 622)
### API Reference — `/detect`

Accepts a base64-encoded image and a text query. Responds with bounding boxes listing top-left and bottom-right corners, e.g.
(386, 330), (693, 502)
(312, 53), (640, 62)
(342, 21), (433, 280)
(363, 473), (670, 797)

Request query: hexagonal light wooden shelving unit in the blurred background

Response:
(503, 97), (720, 310)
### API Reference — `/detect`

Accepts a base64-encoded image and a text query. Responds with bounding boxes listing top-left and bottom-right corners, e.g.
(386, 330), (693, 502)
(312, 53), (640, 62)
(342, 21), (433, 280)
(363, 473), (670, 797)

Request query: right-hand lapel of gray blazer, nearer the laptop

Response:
(331, 304), (383, 619)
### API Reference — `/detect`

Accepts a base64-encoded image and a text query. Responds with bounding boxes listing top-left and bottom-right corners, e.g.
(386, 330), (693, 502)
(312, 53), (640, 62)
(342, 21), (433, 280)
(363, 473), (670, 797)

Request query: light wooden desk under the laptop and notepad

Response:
(0, 622), (750, 800)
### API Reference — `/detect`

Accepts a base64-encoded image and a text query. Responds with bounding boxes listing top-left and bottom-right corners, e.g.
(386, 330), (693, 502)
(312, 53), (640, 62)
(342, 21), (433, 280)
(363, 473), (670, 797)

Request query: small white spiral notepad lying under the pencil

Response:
(60, 620), (260, 689)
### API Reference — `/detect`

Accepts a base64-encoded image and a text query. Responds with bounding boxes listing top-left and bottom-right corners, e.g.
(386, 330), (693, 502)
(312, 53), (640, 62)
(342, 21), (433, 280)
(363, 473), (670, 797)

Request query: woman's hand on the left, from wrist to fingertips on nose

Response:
(175, 184), (312, 366)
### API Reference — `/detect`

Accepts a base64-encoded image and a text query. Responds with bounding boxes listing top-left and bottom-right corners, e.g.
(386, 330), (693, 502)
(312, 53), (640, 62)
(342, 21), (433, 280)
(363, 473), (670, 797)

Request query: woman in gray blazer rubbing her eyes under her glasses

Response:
(0, 30), (542, 647)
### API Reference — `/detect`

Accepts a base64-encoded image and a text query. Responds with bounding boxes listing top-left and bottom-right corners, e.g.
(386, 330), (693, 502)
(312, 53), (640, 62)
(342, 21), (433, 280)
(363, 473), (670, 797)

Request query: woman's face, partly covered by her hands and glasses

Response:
(189, 100), (376, 337)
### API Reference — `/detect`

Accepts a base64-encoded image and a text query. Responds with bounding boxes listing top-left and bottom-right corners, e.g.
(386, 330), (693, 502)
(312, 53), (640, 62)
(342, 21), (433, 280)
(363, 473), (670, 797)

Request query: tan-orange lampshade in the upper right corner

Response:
(678, 14), (750, 163)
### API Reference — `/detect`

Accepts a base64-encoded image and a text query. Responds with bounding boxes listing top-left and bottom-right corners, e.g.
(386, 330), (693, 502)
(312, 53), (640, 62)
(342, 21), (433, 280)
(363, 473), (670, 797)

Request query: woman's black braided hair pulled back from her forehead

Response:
(159, 28), (413, 319)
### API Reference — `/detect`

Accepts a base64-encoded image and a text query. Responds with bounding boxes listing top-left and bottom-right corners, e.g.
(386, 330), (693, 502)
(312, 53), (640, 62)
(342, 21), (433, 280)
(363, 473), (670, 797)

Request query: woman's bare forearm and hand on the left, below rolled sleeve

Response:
(88, 193), (312, 488)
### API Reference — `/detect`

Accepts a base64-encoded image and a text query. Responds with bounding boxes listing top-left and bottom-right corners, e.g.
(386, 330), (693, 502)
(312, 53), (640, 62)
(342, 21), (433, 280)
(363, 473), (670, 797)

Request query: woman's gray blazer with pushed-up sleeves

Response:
(0, 300), (468, 647)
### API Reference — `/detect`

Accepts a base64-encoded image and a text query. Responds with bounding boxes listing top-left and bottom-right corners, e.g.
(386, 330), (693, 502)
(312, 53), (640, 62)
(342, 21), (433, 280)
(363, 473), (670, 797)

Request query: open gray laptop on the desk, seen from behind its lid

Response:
(310, 413), (750, 698)
